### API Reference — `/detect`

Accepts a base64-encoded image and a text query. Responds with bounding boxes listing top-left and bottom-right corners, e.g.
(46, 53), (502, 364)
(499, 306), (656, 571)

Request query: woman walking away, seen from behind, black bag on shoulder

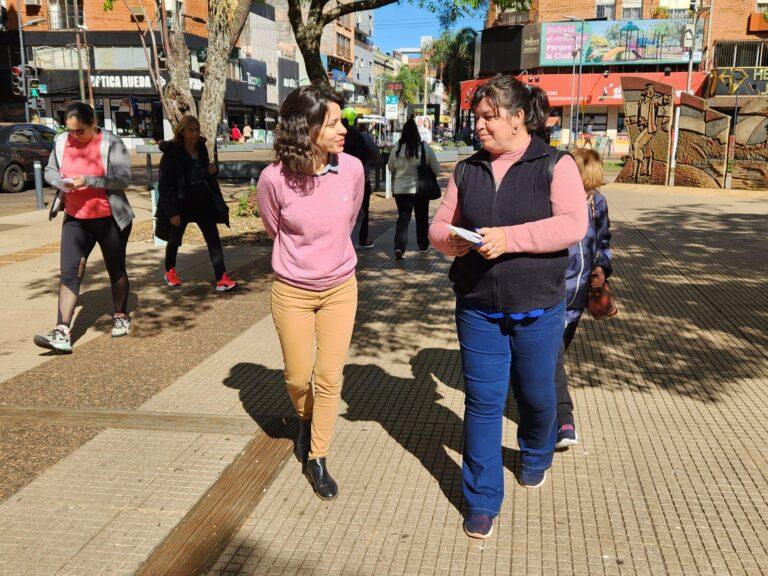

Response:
(388, 117), (440, 260)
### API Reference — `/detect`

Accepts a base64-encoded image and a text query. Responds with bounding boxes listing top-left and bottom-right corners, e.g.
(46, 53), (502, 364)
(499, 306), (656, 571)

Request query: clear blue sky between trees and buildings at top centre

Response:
(373, 0), (485, 52)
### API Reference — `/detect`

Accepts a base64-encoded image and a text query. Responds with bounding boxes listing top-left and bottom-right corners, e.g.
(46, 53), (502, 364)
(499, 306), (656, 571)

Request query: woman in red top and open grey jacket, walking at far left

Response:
(34, 102), (134, 354)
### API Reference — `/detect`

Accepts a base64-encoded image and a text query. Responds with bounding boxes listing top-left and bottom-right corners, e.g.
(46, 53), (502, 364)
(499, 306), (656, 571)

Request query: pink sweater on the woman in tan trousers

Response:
(257, 154), (365, 292)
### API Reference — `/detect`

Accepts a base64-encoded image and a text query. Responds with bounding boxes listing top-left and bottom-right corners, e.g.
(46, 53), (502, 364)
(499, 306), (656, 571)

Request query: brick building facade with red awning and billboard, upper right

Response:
(474, 0), (756, 154)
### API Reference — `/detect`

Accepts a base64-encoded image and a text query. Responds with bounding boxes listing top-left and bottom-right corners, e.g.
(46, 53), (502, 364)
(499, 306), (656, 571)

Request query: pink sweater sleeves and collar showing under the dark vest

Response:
(429, 139), (587, 256)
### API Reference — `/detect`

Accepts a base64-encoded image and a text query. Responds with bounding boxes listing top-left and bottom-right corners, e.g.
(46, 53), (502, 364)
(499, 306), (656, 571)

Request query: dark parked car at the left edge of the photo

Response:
(0, 124), (56, 192)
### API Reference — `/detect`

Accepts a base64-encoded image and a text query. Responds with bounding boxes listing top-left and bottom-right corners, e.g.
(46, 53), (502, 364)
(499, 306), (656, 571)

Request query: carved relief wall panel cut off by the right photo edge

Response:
(731, 98), (768, 189)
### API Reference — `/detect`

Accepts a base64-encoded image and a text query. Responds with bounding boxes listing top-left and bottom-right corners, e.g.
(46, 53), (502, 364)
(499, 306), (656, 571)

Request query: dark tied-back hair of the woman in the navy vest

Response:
(472, 74), (549, 135)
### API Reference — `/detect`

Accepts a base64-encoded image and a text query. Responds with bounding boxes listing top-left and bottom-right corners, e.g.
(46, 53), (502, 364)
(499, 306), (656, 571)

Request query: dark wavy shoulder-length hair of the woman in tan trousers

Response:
(274, 85), (344, 176)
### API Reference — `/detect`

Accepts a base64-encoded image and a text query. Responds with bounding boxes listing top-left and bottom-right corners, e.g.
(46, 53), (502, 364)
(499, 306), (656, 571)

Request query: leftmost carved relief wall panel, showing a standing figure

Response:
(616, 76), (675, 184)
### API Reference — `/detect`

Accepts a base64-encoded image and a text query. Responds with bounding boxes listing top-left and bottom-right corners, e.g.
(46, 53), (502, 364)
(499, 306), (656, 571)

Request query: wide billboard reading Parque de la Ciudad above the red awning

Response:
(540, 18), (704, 66)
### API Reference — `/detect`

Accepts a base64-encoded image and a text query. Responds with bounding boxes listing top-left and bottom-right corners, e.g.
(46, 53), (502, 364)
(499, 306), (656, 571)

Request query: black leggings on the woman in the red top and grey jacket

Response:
(58, 216), (132, 326)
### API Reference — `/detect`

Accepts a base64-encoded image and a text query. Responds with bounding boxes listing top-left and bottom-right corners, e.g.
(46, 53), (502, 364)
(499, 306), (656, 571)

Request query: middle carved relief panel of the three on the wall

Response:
(675, 93), (731, 188)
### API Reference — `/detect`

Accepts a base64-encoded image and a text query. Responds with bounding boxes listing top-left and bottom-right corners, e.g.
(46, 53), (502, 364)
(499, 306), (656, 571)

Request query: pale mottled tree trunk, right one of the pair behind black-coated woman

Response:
(199, 0), (235, 158)
